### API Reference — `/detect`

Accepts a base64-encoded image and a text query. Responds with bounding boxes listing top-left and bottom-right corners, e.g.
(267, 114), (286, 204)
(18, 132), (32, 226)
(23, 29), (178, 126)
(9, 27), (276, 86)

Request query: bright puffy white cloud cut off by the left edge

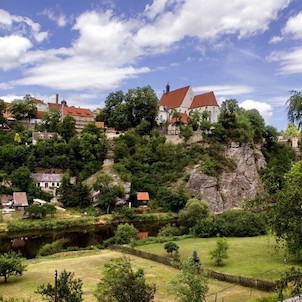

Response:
(0, 35), (32, 70)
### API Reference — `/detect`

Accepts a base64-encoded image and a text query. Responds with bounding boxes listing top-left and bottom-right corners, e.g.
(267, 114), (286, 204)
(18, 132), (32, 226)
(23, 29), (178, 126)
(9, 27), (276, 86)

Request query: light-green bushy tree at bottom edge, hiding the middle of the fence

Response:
(171, 259), (208, 302)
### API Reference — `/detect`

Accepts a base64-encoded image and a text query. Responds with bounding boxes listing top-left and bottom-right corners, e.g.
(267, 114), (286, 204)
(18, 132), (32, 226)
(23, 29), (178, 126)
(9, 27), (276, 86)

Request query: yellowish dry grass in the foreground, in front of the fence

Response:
(0, 250), (268, 302)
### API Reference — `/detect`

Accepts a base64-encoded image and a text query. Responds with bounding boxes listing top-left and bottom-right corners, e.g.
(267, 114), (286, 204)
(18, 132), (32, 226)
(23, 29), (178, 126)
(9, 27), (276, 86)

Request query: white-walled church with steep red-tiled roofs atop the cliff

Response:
(157, 84), (220, 134)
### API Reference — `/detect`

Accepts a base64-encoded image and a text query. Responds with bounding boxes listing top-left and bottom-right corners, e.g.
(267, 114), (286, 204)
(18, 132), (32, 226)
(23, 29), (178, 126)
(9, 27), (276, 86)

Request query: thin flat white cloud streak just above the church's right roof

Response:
(193, 85), (254, 96)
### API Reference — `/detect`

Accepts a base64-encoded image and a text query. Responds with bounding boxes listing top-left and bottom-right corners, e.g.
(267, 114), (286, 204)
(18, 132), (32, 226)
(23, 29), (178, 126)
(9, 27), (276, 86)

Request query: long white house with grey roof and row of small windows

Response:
(31, 173), (63, 196)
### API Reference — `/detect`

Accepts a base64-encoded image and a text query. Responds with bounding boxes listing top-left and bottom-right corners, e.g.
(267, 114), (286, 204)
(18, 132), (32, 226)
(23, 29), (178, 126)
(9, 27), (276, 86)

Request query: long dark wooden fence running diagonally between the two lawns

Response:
(109, 245), (276, 291)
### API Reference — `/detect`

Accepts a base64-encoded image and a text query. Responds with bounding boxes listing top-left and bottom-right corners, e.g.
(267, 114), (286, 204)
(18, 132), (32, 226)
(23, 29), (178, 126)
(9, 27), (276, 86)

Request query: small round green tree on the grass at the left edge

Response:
(0, 252), (27, 282)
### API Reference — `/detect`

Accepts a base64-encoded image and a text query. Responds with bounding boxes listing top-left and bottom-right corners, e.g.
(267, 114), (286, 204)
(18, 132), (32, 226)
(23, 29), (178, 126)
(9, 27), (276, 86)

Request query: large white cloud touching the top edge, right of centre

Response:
(136, 0), (290, 47)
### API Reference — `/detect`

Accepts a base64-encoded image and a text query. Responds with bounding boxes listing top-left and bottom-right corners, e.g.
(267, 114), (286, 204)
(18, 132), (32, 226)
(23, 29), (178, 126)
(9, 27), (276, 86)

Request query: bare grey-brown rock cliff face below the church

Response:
(187, 144), (266, 212)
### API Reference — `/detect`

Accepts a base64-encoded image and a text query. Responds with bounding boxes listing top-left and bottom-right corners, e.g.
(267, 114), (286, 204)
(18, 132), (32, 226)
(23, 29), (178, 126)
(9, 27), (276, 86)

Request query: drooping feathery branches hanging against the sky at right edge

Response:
(286, 91), (302, 130)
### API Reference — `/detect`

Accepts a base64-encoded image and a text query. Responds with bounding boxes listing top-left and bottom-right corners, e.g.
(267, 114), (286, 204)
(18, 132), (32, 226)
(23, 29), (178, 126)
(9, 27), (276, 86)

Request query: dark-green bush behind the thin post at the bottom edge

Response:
(36, 270), (84, 302)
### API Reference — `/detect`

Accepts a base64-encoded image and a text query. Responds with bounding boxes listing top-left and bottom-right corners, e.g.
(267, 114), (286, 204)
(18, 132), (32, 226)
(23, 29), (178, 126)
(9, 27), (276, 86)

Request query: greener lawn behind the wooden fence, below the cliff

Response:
(136, 236), (302, 281)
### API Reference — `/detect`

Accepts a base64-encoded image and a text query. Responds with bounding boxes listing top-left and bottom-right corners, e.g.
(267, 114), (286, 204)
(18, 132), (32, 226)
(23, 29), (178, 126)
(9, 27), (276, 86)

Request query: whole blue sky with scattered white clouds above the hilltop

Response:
(0, 0), (302, 130)
